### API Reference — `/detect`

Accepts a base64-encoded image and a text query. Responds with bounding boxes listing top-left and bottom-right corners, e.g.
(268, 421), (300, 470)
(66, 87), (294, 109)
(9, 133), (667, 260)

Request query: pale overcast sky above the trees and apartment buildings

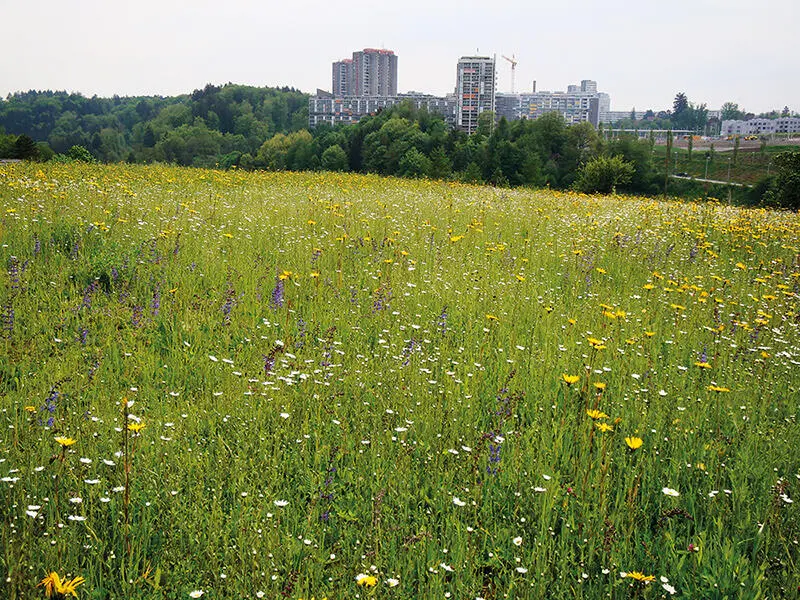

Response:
(0, 0), (800, 113)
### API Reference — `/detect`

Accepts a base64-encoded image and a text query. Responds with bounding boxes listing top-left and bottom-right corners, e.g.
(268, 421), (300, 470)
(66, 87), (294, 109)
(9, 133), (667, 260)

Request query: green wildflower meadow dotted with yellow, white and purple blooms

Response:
(0, 164), (800, 600)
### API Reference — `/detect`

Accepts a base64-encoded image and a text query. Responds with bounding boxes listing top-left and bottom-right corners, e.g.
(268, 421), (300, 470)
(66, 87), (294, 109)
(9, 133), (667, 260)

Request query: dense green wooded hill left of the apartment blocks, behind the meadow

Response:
(0, 84), (308, 167)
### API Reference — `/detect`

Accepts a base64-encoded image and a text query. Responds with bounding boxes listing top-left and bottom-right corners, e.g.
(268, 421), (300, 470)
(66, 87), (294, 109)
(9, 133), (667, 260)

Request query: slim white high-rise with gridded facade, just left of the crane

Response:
(456, 56), (495, 134)
